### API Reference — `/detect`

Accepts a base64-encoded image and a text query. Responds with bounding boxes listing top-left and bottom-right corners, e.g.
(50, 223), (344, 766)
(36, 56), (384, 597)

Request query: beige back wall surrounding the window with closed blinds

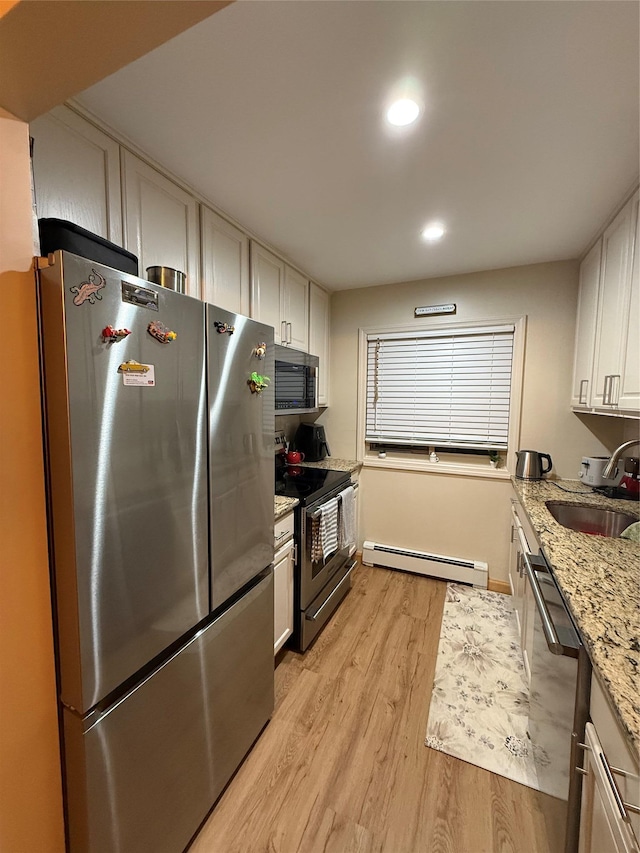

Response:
(321, 261), (623, 580)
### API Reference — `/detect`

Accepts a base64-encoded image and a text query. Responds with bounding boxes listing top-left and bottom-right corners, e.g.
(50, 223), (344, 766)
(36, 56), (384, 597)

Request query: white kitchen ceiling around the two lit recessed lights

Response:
(76, 0), (639, 290)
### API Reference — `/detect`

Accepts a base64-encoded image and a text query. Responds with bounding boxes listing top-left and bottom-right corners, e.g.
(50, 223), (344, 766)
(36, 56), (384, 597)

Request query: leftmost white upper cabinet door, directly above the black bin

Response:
(29, 107), (122, 246)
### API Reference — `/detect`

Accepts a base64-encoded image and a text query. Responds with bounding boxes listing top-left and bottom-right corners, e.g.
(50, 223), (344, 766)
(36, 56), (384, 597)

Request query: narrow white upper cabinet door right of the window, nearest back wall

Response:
(571, 240), (602, 406)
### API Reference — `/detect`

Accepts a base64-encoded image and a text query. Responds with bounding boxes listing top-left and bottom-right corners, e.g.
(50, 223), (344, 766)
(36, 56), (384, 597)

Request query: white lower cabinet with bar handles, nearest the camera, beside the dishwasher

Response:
(579, 675), (640, 853)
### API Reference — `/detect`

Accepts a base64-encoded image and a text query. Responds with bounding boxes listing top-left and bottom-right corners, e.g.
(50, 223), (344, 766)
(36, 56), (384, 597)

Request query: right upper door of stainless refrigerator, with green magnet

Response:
(207, 305), (274, 608)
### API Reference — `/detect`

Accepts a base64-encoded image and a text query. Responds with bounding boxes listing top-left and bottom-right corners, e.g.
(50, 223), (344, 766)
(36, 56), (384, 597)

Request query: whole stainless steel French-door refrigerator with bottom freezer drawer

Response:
(39, 252), (274, 853)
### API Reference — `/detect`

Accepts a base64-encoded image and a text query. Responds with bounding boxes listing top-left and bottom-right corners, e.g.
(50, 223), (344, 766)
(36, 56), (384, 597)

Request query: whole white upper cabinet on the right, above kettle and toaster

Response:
(571, 193), (640, 415)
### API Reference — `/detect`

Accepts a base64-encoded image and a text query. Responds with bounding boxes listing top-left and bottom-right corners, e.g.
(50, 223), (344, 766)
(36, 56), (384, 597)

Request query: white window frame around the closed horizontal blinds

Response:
(357, 316), (527, 479)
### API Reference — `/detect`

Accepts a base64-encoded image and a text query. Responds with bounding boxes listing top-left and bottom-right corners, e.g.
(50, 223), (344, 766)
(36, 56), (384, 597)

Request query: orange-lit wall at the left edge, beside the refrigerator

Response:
(0, 110), (64, 853)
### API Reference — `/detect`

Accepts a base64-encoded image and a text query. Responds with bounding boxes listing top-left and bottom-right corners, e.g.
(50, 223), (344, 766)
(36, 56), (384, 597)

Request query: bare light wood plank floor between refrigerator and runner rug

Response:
(189, 566), (557, 853)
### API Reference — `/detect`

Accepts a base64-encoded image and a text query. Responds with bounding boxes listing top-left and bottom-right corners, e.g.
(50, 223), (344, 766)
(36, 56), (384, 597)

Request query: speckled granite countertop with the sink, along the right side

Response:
(512, 479), (640, 754)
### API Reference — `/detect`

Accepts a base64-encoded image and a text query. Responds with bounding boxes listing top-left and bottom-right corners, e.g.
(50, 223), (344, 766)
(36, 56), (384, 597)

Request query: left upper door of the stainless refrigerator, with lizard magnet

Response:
(40, 253), (209, 714)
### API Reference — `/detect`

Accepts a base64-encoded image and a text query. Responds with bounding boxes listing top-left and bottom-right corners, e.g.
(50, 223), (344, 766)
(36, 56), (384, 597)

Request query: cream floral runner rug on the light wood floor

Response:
(425, 583), (538, 788)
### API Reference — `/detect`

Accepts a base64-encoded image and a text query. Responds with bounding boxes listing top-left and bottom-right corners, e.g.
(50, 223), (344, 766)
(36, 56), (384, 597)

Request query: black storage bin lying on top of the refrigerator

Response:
(38, 219), (138, 275)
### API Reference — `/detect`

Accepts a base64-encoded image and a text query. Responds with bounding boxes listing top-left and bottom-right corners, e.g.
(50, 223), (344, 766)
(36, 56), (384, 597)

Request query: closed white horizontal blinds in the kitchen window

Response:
(365, 326), (514, 450)
